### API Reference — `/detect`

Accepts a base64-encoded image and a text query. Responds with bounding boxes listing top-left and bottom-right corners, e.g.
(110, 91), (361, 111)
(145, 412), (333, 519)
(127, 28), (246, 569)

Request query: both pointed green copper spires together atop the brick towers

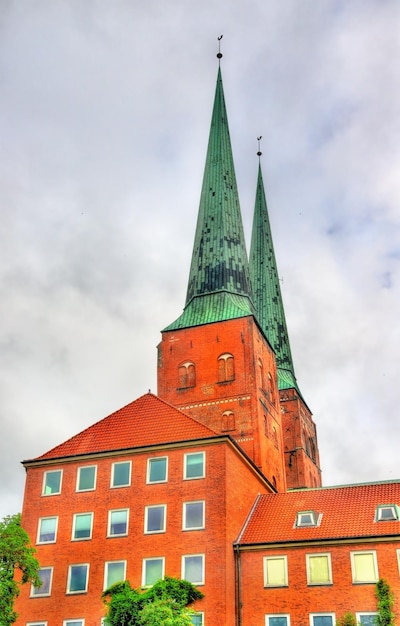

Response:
(164, 62), (297, 389)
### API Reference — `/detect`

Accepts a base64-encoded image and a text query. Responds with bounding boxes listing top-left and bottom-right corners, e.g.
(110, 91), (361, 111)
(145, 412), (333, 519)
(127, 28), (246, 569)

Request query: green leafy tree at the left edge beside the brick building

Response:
(0, 513), (41, 626)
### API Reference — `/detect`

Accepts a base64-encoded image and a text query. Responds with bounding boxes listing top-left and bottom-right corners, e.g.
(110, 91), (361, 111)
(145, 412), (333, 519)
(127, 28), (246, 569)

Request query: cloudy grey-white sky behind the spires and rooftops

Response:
(0, 0), (400, 517)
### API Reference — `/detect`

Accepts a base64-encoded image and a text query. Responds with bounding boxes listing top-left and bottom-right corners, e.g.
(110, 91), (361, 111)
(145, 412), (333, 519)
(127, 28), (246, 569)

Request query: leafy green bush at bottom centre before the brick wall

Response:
(102, 576), (203, 626)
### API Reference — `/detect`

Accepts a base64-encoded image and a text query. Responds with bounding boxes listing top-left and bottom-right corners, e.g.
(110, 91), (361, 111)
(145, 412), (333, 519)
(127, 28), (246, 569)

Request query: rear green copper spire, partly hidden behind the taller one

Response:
(250, 162), (299, 391)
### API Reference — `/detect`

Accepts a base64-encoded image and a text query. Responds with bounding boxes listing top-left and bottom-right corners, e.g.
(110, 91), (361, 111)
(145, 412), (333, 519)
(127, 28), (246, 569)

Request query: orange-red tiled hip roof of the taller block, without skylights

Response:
(25, 393), (216, 463)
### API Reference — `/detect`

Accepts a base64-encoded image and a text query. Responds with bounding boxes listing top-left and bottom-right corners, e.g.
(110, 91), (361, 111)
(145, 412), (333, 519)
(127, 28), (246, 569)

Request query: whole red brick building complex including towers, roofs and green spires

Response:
(16, 58), (400, 626)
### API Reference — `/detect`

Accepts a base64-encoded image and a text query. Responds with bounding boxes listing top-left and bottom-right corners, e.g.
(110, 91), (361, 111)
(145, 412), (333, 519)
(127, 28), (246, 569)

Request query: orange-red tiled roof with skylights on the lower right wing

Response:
(238, 481), (400, 545)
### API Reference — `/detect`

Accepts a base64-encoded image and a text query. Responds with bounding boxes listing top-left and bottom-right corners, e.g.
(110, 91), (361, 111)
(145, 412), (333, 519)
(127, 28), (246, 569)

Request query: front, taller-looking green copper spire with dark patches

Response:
(165, 68), (254, 330)
